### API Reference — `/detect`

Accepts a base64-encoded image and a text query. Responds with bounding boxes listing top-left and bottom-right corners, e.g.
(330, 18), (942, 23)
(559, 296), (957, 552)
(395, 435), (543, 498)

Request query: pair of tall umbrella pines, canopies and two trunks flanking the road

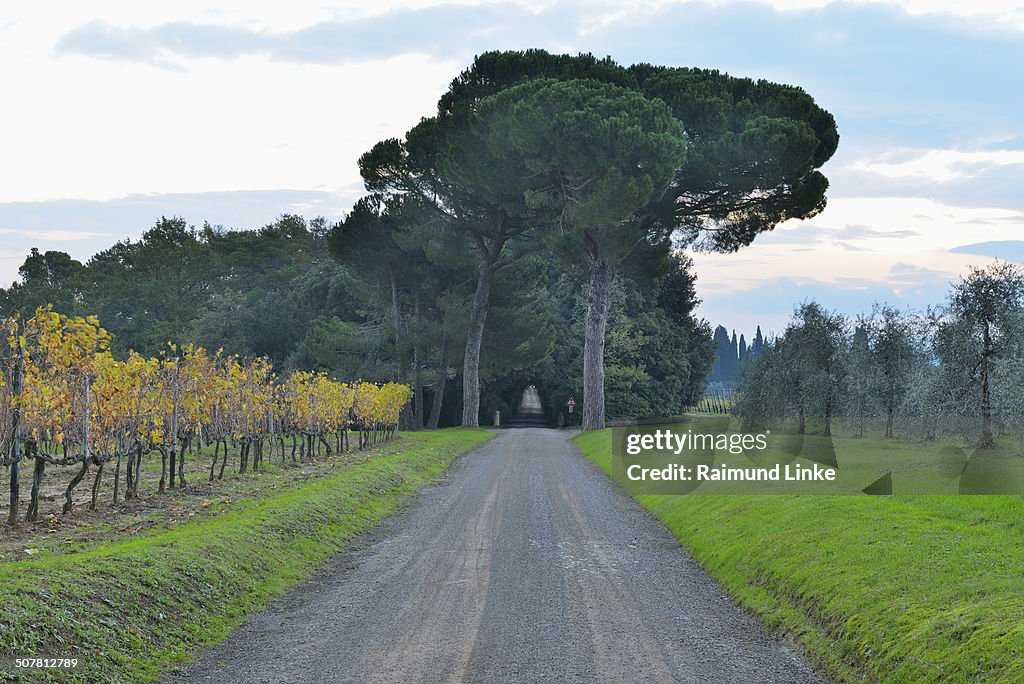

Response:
(359, 50), (839, 429)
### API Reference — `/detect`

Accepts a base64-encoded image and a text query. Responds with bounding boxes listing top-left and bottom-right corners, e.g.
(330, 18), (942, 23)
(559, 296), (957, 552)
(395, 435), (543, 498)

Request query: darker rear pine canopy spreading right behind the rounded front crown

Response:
(438, 50), (839, 251)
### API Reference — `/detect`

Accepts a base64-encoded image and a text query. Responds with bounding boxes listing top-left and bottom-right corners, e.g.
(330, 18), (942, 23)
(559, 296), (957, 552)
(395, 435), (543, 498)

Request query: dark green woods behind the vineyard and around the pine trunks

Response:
(0, 216), (711, 427)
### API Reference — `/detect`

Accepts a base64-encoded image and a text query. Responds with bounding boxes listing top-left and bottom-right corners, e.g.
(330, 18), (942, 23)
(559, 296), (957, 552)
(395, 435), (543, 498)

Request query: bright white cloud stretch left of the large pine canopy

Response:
(0, 55), (458, 202)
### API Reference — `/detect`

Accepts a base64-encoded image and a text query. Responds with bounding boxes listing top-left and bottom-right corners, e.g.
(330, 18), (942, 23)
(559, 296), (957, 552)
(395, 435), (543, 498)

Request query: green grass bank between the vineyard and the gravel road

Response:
(0, 430), (490, 682)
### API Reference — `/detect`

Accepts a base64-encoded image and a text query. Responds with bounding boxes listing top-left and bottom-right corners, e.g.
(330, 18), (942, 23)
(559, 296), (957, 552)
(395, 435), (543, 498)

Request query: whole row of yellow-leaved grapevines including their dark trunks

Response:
(0, 307), (412, 524)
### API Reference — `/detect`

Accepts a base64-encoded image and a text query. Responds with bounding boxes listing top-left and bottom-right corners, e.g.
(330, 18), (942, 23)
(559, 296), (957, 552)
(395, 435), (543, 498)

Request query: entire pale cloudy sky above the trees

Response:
(0, 0), (1024, 339)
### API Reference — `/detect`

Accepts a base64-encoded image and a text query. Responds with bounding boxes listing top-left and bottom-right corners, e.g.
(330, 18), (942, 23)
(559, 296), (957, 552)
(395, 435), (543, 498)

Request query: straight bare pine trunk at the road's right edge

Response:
(583, 256), (612, 430)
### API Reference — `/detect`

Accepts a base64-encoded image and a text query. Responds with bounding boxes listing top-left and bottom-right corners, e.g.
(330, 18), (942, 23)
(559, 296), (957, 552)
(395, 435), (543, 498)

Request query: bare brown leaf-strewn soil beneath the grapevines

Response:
(0, 442), (394, 562)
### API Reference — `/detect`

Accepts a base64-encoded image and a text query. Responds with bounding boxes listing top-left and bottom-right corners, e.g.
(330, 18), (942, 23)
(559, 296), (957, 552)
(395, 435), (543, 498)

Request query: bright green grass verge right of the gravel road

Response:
(577, 419), (1024, 682)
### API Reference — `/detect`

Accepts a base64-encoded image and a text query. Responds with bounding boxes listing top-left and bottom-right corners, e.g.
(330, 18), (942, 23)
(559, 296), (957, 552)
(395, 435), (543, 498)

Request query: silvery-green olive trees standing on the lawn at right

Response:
(735, 261), (1024, 448)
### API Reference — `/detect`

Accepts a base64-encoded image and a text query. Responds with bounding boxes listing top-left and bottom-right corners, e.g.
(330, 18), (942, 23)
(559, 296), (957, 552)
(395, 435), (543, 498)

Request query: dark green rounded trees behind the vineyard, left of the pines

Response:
(0, 216), (348, 368)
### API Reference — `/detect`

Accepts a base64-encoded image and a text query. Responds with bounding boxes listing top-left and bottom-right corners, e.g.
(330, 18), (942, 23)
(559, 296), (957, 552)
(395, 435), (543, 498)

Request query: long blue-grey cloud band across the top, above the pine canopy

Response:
(55, 2), (1024, 157)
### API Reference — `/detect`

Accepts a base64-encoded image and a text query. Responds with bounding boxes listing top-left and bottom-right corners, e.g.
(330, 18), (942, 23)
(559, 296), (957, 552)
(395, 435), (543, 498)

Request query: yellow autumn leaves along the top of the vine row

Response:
(0, 307), (412, 455)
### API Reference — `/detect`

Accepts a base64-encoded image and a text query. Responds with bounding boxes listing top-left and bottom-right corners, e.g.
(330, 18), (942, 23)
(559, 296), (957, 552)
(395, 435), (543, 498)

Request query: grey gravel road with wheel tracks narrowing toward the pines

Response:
(169, 428), (820, 684)
